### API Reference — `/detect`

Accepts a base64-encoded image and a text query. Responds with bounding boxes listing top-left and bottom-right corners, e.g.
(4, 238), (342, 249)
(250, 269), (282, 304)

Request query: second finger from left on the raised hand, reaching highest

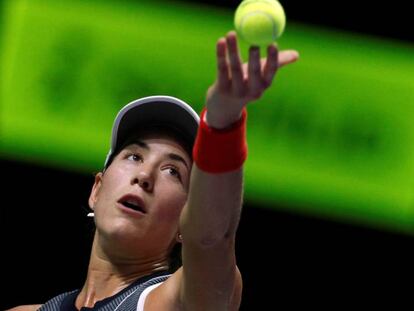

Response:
(226, 31), (244, 95)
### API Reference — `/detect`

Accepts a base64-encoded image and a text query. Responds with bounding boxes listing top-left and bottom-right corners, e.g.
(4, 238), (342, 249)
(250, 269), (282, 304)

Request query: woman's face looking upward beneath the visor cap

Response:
(89, 133), (192, 259)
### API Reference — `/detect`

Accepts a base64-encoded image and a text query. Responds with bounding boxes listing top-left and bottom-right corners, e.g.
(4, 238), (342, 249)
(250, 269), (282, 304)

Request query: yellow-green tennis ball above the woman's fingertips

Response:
(234, 0), (286, 46)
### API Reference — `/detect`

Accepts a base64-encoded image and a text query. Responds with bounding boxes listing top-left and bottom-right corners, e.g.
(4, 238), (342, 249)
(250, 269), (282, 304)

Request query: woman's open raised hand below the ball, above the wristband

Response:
(206, 31), (299, 129)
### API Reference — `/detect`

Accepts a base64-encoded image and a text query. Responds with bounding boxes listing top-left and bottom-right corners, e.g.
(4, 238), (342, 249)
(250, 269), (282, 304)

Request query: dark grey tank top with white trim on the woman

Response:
(38, 272), (171, 311)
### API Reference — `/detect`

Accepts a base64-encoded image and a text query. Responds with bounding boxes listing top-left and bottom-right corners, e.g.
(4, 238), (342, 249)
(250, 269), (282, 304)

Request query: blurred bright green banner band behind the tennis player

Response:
(0, 0), (414, 234)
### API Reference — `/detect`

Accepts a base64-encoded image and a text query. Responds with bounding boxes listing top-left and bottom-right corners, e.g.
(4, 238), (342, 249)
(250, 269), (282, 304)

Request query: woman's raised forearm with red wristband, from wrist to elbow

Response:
(181, 100), (247, 245)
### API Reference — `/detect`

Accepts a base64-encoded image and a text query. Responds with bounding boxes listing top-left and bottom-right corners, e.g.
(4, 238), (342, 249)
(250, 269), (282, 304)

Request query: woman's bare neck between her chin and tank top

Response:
(76, 235), (169, 309)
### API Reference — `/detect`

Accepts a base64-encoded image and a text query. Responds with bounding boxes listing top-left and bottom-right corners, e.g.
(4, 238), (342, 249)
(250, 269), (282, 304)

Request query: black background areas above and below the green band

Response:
(0, 0), (414, 310)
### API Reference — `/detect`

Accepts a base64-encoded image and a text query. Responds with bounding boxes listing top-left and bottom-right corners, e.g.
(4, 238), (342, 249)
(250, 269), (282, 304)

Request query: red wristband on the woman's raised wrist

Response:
(193, 109), (247, 173)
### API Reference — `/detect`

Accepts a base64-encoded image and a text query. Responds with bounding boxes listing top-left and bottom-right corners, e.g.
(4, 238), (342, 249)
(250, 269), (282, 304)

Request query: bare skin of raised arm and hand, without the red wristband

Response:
(180, 32), (298, 311)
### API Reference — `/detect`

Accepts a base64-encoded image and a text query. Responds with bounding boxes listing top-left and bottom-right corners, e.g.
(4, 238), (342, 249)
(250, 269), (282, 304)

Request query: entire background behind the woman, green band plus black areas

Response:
(0, 0), (414, 310)
